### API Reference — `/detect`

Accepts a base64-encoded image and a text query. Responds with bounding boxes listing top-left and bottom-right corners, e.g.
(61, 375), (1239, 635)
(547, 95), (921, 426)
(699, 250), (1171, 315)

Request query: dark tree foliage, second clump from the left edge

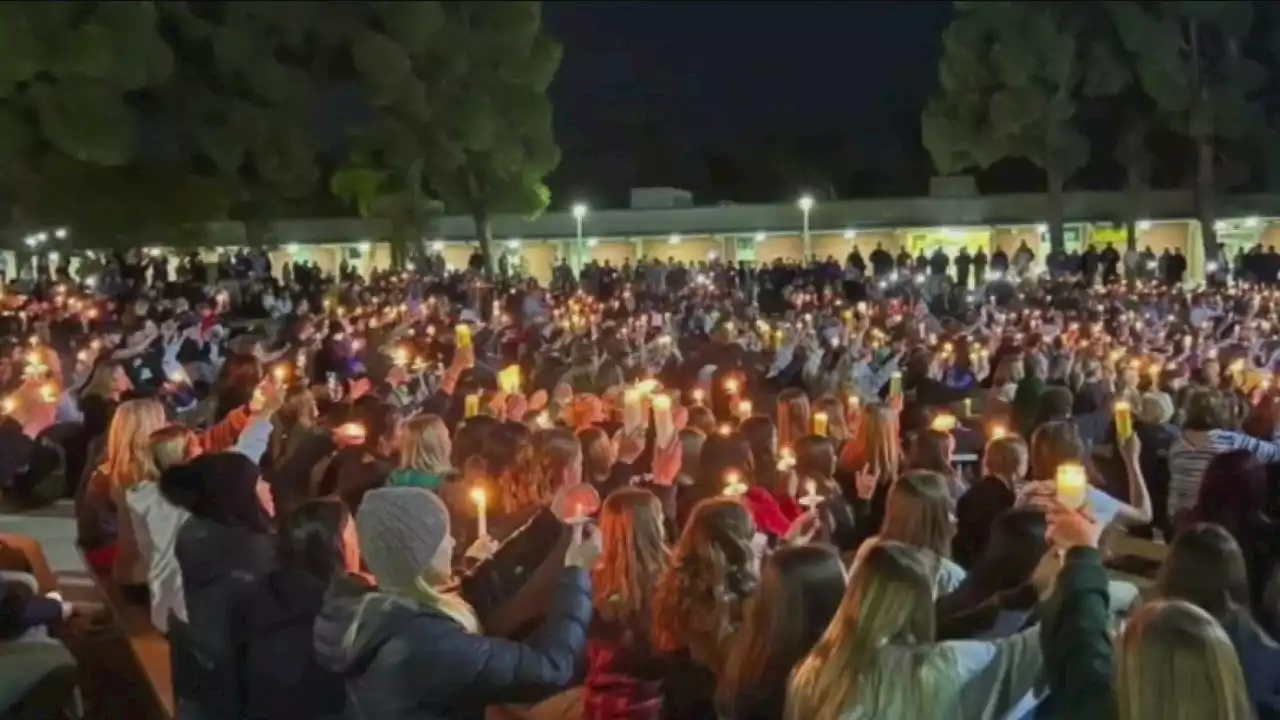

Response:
(159, 1), (335, 210)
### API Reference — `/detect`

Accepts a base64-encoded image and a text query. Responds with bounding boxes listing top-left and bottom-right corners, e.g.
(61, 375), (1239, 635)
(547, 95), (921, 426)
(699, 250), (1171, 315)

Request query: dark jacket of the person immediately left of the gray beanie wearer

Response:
(241, 568), (347, 720)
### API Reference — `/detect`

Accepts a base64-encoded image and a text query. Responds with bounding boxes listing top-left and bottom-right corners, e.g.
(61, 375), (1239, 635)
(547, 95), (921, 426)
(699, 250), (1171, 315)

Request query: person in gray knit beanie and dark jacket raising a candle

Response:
(315, 488), (600, 720)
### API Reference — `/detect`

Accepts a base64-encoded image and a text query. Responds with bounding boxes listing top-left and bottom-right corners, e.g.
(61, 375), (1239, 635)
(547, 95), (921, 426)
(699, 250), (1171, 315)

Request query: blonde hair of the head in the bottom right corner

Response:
(1115, 600), (1253, 720)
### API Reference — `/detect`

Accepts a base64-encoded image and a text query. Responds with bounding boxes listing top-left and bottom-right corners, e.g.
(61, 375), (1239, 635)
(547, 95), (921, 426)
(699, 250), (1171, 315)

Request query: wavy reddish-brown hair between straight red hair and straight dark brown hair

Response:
(653, 497), (758, 671)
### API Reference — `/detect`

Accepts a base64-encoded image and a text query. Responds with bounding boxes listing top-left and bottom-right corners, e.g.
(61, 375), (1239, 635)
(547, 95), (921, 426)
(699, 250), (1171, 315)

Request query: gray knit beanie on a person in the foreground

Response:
(356, 487), (449, 588)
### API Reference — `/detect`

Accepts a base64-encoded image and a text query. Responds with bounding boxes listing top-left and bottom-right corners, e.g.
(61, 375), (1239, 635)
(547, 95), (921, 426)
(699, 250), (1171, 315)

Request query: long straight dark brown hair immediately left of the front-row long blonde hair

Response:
(717, 544), (845, 717)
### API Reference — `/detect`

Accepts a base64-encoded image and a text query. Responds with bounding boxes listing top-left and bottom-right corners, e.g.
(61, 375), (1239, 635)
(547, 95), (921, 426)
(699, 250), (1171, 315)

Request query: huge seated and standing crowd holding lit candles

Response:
(0, 242), (1280, 720)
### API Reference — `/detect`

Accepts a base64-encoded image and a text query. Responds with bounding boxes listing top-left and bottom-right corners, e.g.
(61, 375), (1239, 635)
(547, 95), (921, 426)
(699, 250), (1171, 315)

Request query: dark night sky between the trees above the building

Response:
(543, 1), (951, 205)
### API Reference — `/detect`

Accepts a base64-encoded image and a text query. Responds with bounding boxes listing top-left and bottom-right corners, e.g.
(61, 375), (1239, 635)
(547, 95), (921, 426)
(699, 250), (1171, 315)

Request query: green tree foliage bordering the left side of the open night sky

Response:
(337, 1), (561, 269)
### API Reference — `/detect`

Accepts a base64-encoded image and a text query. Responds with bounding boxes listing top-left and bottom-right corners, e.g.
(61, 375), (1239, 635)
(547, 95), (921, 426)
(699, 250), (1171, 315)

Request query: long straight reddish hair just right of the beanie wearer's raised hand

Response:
(591, 488), (667, 639)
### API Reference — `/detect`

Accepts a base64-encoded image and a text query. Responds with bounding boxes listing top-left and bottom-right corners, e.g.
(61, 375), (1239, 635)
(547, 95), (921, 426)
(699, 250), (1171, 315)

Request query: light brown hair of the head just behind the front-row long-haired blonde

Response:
(879, 470), (955, 557)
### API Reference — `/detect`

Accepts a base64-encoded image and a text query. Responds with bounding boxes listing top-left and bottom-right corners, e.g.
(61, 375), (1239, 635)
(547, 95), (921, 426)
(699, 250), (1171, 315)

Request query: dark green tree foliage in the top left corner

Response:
(0, 1), (173, 169)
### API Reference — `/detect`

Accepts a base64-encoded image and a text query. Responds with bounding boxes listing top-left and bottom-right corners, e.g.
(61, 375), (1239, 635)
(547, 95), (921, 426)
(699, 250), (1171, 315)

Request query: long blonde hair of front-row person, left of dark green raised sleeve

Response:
(785, 539), (945, 720)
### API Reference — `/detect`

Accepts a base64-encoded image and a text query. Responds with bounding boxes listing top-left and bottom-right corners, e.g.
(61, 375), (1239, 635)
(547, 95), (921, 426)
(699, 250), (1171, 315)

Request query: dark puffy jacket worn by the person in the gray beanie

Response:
(315, 569), (591, 720)
